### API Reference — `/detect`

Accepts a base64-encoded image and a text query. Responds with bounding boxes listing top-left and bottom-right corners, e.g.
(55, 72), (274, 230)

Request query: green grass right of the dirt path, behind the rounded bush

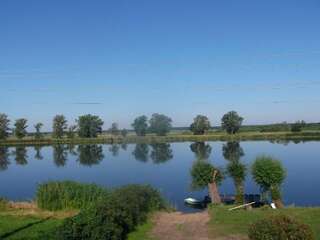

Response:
(209, 206), (320, 240)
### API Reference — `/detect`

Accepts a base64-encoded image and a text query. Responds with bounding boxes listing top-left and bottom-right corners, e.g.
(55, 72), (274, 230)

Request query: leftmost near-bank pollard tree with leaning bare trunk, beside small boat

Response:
(190, 161), (223, 204)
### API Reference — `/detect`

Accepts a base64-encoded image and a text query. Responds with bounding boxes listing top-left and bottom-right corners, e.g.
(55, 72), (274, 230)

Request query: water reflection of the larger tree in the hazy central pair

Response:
(150, 143), (173, 164)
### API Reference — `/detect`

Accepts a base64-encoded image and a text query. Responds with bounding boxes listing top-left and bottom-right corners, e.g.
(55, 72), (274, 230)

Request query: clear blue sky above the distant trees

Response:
(0, 0), (320, 129)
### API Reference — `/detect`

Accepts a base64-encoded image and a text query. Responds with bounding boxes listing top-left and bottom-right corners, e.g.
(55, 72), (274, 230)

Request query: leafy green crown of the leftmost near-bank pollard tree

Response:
(190, 161), (223, 190)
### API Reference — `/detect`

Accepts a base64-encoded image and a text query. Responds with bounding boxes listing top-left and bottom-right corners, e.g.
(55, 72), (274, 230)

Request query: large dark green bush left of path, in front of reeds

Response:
(56, 185), (164, 240)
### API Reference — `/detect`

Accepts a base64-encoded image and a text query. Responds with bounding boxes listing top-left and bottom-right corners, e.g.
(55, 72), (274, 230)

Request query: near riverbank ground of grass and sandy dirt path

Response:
(0, 203), (320, 240)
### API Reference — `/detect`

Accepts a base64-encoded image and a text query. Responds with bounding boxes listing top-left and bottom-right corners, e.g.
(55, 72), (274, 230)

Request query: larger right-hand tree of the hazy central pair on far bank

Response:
(149, 113), (172, 136)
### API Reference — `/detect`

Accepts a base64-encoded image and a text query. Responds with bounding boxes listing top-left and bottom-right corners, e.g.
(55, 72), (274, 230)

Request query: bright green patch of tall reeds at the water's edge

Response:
(36, 181), (108, 211)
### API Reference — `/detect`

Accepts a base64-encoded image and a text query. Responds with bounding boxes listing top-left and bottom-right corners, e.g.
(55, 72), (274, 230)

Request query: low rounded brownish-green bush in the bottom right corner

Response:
(248, 215), (315, 240)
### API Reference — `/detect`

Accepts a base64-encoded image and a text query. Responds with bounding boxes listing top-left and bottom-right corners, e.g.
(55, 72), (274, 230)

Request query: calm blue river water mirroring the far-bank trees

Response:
(0, 141), (320, 212)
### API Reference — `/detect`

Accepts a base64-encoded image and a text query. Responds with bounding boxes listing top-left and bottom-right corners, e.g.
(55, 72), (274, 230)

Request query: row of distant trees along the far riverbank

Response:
(0, 111), (312, 139)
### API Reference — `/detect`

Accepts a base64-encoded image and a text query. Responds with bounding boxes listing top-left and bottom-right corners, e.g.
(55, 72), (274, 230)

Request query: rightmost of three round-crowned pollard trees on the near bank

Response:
(252, 155), (286, 208)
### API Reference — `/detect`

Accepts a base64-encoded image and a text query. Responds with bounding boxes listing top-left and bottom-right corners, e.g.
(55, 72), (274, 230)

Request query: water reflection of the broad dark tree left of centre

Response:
(77, 144), (104, 166)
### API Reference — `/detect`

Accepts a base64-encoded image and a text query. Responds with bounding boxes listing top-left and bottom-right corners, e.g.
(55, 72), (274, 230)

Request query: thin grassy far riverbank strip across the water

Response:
(0, 131), (320, 146)
